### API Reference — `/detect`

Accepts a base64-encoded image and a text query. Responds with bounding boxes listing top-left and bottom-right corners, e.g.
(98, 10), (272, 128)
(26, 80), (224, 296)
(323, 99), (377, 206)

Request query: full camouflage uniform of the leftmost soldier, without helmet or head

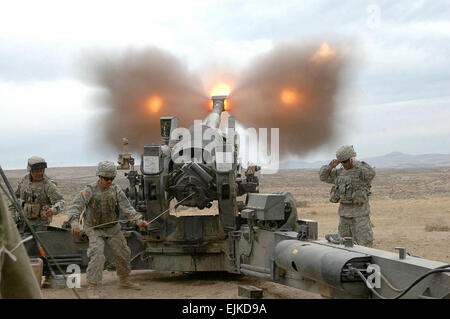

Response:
(10, 174), (64, 231)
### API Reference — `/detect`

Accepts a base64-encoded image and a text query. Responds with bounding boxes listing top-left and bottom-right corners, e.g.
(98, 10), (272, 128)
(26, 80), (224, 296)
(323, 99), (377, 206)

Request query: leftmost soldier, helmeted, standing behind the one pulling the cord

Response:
(10, 156), (64, 231)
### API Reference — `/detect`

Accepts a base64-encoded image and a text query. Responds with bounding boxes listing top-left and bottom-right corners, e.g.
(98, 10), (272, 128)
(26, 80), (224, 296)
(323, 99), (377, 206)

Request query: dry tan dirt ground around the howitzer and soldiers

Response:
(1, 167), (450, 299)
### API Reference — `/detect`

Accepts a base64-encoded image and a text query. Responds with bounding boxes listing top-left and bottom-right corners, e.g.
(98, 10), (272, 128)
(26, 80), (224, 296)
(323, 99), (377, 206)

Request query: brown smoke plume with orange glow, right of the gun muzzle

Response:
(230, 44), (346, 155)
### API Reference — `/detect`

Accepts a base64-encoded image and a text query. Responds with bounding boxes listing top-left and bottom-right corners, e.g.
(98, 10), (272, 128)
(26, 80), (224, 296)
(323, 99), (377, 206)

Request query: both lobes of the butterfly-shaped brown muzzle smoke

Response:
(87, 43), (348, 156)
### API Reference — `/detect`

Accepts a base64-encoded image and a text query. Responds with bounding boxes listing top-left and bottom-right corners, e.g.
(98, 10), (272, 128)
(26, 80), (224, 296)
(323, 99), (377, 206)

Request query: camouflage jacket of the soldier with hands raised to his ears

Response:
(319, 160), (375, 217)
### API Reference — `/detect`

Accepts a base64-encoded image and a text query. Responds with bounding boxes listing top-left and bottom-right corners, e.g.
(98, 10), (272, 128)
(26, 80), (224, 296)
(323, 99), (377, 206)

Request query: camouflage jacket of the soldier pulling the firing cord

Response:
(66, 181), (142, 227)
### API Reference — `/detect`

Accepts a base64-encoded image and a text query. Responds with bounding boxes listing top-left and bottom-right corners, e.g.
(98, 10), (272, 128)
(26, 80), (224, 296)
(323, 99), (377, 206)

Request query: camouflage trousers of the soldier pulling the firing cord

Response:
(85, 224), (131, 285)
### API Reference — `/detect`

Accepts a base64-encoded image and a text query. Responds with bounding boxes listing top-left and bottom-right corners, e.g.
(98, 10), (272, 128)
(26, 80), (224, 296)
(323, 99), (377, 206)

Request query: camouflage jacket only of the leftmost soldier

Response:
(16, 174), (65, 218)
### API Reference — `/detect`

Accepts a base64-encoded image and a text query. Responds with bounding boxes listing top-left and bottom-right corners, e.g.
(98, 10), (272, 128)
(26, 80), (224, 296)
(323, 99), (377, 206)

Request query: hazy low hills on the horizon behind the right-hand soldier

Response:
(280, 152), (450, 169)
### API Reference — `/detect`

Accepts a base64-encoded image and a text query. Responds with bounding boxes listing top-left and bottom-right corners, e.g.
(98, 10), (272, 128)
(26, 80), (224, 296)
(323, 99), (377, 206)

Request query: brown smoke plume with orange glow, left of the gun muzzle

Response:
(87, 48), (208, 151)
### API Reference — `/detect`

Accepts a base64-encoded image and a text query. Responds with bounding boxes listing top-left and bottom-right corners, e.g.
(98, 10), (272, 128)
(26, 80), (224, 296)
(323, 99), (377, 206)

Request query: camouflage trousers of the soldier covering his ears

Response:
(339, 216), (373, 247)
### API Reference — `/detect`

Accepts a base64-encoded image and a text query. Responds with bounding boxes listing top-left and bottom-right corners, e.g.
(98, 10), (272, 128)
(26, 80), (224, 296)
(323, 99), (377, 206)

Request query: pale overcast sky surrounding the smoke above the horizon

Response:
(0, 0), (450, 169)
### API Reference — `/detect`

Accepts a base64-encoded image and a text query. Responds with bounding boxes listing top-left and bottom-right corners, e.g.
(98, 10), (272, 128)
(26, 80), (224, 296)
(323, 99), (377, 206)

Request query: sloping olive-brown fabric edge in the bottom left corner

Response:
(0, 195), (42, 299)
